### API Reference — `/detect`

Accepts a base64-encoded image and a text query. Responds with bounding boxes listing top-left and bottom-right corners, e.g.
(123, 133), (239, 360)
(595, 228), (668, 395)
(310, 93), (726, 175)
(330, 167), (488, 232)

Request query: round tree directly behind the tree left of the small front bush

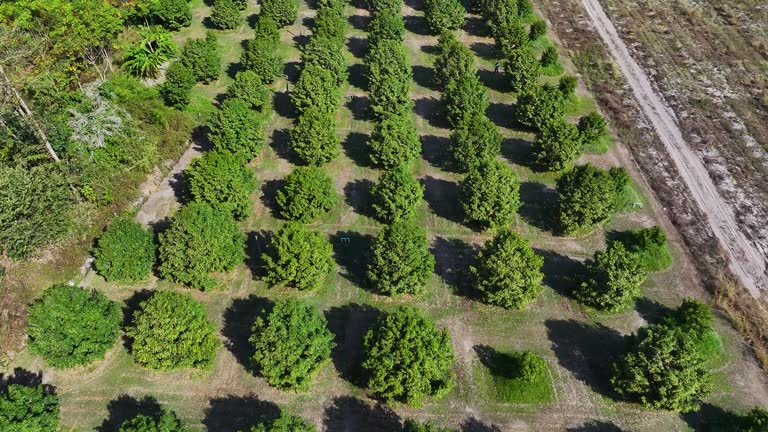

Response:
(368, 219), (435, 295)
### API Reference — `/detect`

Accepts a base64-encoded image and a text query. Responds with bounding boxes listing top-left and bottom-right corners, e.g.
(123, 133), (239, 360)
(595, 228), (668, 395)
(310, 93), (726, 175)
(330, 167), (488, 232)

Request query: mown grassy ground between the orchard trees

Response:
(7, 0), (765, 432)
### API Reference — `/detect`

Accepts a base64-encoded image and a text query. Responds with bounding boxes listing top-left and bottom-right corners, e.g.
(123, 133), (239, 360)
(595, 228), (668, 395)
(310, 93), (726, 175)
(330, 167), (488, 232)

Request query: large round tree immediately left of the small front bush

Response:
(362, 307), (454, 405)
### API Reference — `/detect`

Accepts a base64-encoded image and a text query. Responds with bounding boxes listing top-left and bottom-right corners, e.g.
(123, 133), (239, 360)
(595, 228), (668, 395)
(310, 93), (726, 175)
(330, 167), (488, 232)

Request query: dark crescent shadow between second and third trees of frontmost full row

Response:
(220, 294), (274, 372)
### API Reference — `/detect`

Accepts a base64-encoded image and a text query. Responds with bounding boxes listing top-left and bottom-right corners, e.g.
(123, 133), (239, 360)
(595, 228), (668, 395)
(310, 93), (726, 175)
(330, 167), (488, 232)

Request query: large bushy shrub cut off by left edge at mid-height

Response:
(0, 166), (71, 259)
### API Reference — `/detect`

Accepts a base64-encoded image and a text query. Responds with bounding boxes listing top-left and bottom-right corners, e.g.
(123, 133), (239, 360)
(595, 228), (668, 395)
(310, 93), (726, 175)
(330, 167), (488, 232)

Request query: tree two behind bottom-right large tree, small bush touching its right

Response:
(557, 164), (629, 234)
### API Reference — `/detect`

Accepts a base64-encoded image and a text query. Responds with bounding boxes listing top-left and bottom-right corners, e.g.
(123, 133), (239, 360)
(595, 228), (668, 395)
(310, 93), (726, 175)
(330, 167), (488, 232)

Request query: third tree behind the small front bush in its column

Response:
(451, 113), (502, 172)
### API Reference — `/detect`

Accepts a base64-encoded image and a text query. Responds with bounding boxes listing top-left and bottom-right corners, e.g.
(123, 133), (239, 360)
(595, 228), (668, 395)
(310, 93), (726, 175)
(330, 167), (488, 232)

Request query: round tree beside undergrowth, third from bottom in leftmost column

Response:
(93, 217), (155, 282)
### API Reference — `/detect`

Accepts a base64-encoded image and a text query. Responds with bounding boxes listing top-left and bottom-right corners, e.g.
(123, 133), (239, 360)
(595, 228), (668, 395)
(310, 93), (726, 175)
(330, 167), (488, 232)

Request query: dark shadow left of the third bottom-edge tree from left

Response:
(203, 394), (280, 431)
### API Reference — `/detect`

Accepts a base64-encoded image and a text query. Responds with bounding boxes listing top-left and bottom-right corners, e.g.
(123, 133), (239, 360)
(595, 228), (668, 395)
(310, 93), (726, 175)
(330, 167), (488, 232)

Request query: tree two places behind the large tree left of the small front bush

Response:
(371, 165), (424, 223)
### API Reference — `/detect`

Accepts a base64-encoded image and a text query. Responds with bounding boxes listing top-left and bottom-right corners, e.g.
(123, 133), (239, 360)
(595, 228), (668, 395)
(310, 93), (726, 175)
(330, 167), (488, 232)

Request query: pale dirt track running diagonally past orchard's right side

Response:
(582, 0), (768, 297)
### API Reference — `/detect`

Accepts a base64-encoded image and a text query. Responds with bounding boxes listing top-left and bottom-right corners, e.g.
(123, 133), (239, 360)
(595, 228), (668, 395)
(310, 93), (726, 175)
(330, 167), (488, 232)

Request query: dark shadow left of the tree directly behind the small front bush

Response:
(430, 237), (480, 300)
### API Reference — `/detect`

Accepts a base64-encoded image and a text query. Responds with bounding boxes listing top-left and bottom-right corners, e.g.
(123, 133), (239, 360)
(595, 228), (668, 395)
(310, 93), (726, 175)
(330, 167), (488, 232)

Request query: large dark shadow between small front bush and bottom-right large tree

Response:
(544, 319), (624, 397)
